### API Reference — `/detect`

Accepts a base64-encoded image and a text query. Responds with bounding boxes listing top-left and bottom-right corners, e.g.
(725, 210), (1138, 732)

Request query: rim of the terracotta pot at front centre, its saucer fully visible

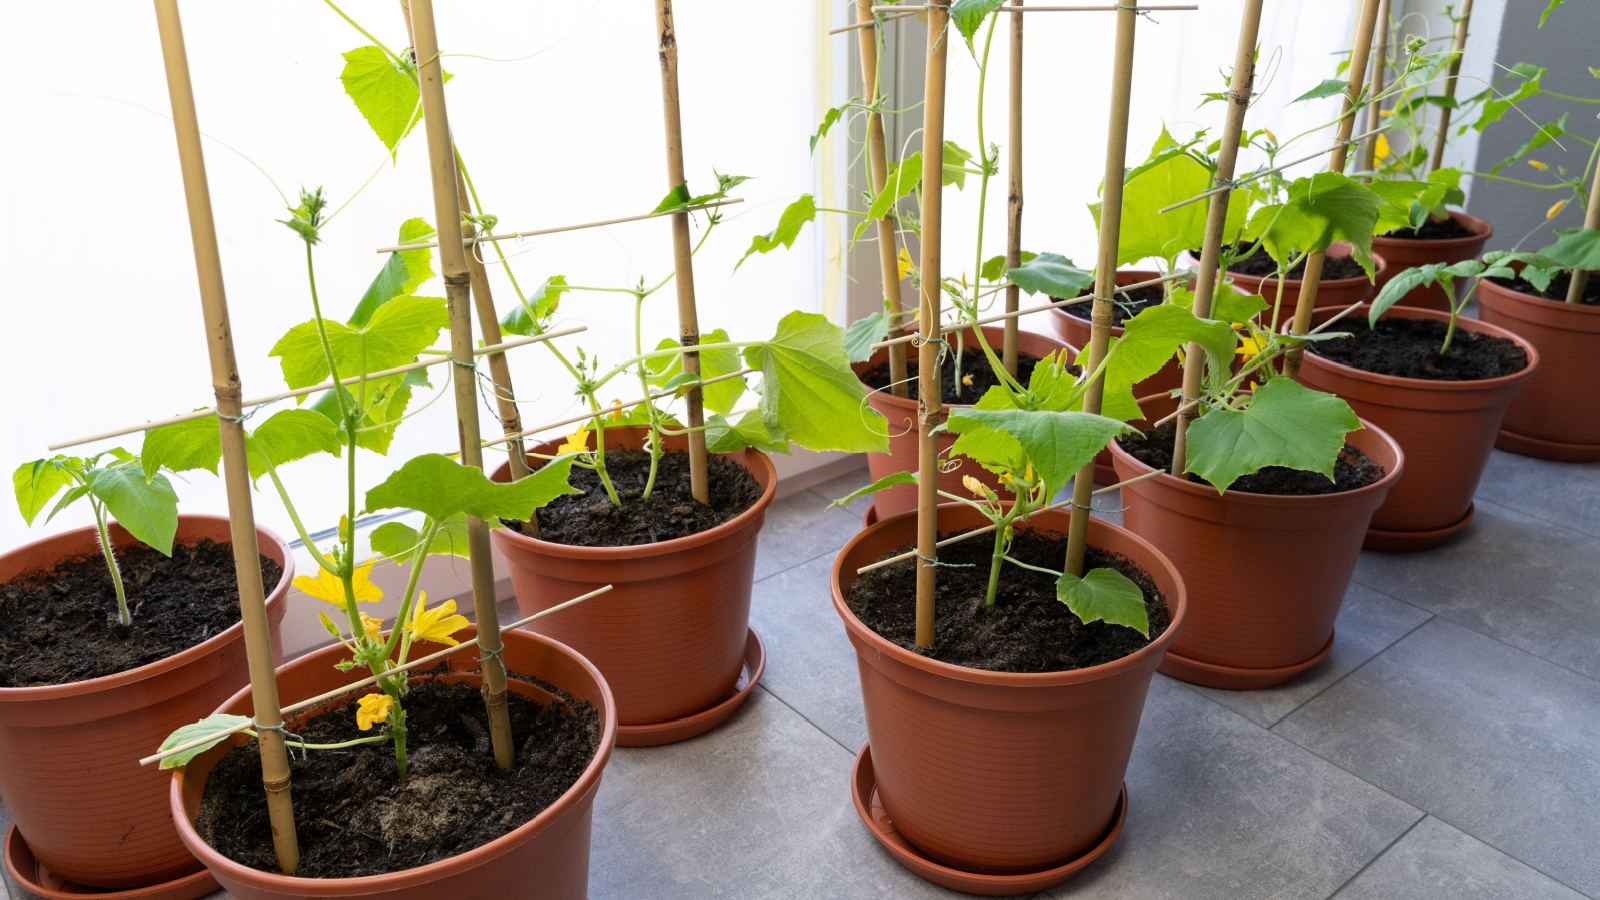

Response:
(829, 503), (1189, 689)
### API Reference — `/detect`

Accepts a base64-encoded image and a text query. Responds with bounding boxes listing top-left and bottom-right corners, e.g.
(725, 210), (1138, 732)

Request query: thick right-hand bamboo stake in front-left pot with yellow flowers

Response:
(411, 0), (517, 770)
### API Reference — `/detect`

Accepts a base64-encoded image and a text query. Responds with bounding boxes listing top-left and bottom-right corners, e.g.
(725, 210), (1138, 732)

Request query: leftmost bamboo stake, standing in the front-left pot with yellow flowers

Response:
(155, 0), (300, 874)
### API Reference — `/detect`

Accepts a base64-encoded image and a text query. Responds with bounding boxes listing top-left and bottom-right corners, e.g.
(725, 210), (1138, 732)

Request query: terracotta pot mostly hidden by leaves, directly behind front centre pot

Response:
(853, 325), (1078, 519)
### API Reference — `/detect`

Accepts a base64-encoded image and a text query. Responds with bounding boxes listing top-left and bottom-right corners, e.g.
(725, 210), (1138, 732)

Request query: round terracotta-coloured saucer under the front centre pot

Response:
(850, 745), (1128, 897)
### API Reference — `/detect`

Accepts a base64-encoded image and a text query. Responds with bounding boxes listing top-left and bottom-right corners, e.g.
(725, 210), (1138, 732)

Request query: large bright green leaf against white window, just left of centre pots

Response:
(744, 311), (888, 453)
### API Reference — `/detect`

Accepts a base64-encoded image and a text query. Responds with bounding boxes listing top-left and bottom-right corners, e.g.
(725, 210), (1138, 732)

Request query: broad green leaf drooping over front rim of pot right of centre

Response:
(1187, 378), (1362, 493)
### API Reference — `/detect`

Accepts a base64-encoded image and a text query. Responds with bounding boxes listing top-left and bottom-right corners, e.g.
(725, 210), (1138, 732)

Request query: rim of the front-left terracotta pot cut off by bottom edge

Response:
(168, 625), (616, 897)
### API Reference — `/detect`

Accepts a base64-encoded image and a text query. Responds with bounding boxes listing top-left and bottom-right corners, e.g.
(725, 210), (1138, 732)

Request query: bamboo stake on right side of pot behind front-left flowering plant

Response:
(656, 0), (710, 504)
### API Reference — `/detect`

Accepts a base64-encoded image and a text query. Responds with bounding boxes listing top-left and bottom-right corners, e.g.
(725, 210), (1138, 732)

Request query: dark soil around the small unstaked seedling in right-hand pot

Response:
(1309, 317), (1528, 381)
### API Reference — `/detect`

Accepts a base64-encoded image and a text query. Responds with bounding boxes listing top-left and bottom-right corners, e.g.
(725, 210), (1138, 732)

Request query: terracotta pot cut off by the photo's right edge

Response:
(1478, 273), (1600, 463)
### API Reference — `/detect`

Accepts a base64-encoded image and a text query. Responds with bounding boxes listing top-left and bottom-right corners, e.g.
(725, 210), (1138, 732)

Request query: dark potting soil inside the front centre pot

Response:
(848, 532), (1171, 673)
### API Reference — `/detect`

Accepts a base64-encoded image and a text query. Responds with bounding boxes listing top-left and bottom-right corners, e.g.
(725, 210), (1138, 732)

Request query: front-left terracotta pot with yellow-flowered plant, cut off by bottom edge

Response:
(168, 628), (616, 900)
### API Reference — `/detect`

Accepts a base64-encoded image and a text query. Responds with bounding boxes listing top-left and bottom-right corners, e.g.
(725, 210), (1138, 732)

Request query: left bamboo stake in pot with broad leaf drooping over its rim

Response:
(1170, 0), (1254, 479)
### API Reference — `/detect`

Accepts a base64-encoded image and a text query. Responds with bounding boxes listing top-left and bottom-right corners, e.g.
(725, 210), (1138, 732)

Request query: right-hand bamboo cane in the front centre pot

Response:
(1064, 6), (1139, 575)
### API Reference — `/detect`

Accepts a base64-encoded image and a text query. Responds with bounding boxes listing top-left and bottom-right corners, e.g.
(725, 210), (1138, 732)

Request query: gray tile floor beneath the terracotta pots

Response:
(0, 452), (1600, 900)
